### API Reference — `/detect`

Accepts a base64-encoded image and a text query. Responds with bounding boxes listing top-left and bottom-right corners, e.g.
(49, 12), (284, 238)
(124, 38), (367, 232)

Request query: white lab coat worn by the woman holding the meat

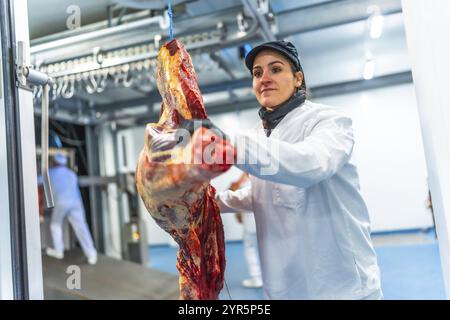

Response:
(217, 100), (382, 299)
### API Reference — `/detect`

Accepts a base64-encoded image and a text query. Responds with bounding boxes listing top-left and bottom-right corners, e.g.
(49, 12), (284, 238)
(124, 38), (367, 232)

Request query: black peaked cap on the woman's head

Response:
(245, 40), (303, 72)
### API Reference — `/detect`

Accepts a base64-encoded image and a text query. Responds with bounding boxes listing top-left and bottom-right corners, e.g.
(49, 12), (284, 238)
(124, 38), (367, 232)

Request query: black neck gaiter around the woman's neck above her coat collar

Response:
(258, 90), (306, 137)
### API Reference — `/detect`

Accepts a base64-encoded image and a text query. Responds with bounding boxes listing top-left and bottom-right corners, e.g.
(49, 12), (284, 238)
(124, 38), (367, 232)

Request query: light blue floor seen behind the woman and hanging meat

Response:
(149, 231), (445, 300)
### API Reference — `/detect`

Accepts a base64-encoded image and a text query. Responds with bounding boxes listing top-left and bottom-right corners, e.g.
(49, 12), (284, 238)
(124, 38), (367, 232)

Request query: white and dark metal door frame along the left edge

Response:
(0, 0), (43, 300)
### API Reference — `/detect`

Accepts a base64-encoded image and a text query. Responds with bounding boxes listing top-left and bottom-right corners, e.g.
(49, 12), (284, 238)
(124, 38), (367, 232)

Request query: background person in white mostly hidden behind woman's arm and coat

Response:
(230, 172), (263, 288)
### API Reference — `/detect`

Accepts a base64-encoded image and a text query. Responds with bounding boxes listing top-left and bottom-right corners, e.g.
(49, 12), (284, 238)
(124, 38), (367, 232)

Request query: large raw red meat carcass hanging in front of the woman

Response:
(136, 39), (235, 299)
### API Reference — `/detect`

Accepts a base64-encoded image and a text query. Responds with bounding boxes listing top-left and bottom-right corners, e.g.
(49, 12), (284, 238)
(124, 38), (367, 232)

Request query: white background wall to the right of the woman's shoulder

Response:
(317, 84), (432, 231)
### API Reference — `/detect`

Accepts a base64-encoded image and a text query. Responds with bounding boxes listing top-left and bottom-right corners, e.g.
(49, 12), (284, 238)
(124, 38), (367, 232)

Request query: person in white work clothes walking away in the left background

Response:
(40, 153), (97, 264)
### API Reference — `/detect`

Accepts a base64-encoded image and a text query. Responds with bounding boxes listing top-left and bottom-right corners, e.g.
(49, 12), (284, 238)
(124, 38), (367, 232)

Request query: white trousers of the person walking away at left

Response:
(50, 204), (97, 258)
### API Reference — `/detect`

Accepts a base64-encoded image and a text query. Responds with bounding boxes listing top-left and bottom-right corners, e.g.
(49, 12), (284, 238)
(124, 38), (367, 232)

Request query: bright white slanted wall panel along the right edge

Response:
(402, 0), (450, 298)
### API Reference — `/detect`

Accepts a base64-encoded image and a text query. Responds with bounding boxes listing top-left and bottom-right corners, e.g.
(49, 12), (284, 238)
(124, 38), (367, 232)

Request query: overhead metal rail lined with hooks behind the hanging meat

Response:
(30, 16), (257, 100)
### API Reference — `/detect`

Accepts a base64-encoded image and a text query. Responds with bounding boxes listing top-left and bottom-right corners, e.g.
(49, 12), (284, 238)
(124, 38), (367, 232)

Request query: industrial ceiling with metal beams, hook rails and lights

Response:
(28, 0), (410, 125)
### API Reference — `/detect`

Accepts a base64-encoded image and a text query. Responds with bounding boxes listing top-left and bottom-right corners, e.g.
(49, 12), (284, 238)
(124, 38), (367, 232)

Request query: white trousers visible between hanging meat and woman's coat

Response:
(242, 213), (261, 278)
